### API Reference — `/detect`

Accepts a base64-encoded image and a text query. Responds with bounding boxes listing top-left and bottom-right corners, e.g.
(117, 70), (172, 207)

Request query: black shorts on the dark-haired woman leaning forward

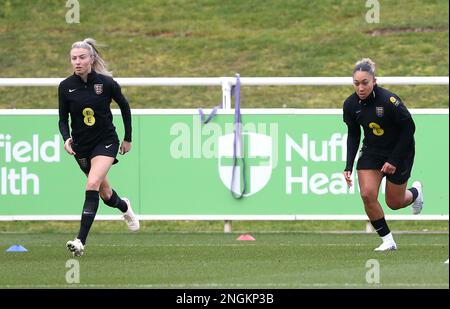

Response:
(356, 152), (414, 185)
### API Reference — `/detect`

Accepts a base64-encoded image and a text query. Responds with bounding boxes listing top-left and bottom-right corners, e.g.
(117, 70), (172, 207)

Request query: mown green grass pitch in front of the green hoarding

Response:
(0, 231), (449, 289)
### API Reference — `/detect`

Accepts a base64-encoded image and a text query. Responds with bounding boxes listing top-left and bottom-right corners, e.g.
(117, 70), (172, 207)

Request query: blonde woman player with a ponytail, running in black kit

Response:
(58, 38), (139, 256)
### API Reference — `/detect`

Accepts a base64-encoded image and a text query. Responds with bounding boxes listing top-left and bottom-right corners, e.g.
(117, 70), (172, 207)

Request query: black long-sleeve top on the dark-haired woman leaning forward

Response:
(343, 85), (415, 171)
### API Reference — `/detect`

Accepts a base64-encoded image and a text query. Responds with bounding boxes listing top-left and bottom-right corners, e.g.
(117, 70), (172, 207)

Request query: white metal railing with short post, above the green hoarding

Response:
(0, 76), (449, 109)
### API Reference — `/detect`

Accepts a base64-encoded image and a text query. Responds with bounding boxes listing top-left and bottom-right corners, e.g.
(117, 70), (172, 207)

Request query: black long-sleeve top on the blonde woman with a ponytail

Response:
(58, 70), (131, 151)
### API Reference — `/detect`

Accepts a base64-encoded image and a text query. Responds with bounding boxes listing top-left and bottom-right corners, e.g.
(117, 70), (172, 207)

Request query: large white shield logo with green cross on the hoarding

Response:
(218, 132), (272, 196)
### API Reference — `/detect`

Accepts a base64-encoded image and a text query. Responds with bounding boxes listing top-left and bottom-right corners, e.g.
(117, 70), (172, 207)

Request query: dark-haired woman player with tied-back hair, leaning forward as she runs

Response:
(344, 58), (423, 251)
